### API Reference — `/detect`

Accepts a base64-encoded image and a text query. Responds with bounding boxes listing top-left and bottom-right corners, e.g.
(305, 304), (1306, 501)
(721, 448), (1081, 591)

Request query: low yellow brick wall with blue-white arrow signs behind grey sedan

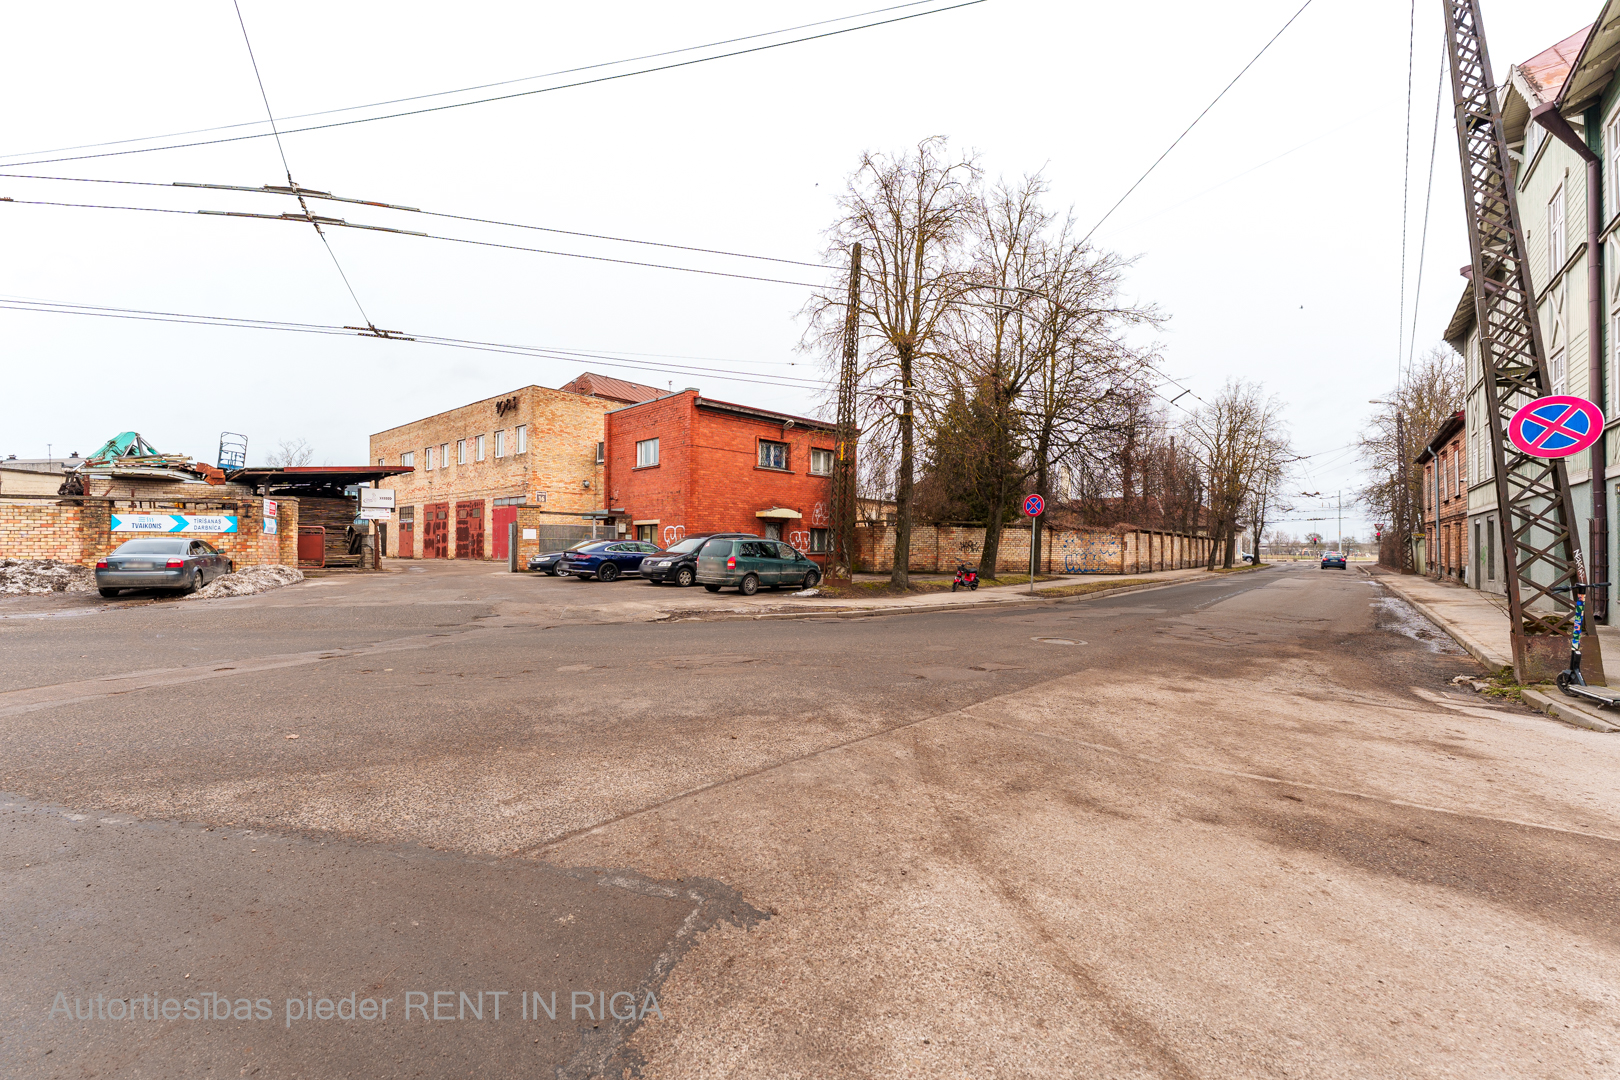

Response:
(0, 499), (298, 567)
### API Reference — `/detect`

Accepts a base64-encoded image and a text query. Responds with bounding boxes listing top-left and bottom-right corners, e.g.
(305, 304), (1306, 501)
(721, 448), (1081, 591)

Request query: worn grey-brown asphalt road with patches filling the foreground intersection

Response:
(0, 567), (1620, 1077)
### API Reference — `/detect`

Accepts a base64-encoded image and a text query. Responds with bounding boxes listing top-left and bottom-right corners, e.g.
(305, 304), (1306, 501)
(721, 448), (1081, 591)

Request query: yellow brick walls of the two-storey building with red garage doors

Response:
(369, 385), (619, 559)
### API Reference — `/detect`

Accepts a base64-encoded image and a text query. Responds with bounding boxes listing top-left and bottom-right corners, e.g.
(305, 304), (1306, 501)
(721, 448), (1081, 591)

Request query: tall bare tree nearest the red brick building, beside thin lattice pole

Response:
(805, 136), (978, 588)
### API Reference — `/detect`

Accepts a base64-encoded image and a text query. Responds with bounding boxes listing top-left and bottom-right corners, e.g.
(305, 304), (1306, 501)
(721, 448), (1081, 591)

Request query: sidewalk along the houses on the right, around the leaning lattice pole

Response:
(1362, 567), (1620, 732)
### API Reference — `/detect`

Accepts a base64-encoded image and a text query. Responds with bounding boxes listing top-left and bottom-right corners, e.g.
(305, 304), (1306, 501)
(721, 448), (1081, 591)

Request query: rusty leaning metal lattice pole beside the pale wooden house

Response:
(1442, 0), (1602, 683)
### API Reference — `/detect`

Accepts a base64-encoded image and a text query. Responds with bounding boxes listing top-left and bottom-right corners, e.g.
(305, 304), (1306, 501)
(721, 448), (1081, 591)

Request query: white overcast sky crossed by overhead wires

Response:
(0, 0), (1599, 536)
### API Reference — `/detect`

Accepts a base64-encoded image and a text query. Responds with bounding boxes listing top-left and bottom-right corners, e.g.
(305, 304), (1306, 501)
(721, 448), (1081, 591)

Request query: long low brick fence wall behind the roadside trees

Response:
(855, 525), (1210, 573)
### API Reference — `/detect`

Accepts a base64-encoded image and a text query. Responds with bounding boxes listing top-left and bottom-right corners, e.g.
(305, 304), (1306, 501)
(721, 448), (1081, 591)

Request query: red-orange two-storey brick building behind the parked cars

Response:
(603, 390), (836, 560)
